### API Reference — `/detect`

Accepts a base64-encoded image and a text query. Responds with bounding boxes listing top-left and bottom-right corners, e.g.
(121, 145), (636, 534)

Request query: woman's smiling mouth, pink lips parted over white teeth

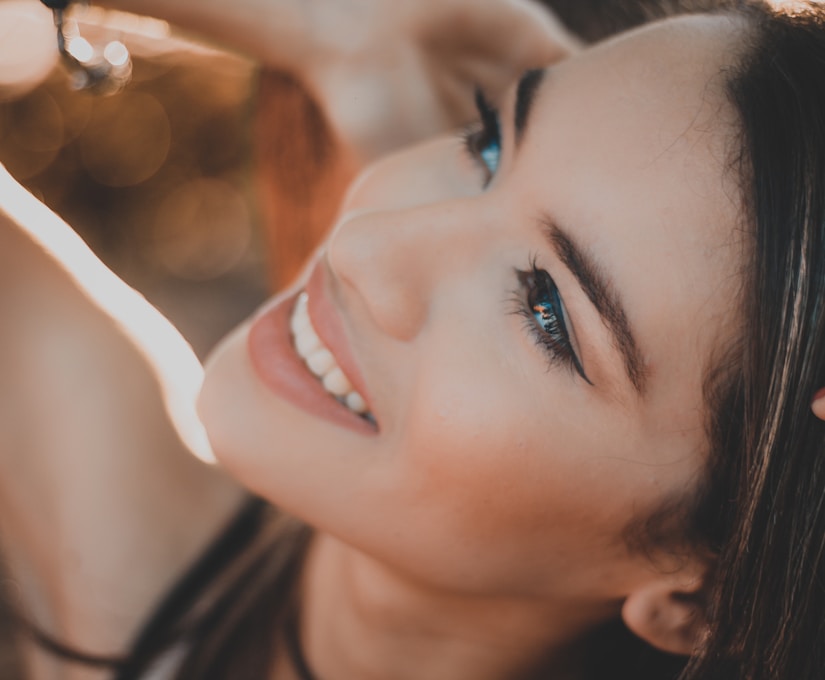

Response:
(243, 261), (377, 434)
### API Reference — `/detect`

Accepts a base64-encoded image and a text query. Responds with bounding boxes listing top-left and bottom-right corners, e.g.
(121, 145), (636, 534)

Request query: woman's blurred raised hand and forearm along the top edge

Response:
(100, 0), (579, 164)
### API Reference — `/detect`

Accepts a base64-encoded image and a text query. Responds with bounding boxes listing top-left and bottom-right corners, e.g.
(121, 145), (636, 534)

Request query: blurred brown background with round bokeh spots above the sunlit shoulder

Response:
(0, 0), (266, 358)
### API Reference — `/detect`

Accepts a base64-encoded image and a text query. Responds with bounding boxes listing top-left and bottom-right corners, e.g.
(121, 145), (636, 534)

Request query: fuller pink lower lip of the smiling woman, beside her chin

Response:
(247, 286), (375, 434)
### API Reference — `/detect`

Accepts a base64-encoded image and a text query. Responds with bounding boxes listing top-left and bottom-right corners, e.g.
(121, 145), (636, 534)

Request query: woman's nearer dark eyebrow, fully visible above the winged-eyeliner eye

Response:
(541, 217), (647, 396)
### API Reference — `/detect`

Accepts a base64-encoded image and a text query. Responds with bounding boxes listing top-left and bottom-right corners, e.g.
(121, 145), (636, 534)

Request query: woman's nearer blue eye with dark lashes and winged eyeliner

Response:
(513, 255), (593, 385)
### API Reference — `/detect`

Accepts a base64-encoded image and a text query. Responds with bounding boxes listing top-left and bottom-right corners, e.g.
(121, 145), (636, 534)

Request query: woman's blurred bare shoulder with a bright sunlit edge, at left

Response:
(0, 168), (242, 664)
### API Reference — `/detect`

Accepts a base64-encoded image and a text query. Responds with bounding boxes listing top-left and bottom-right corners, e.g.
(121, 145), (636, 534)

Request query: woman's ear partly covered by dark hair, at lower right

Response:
(622, 571), (707, 655)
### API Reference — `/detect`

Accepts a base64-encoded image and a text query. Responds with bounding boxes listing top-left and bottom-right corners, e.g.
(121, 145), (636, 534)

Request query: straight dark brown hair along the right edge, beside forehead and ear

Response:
(686, 3), (825, 680)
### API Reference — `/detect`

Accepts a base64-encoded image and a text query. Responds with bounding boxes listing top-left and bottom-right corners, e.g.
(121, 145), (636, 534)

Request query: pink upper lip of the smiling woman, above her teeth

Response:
(306, 258), (374, 415)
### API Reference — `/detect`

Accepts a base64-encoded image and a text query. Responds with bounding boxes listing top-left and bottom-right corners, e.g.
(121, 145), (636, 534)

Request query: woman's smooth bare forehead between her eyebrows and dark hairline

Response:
(517, 16), (741, 410)
